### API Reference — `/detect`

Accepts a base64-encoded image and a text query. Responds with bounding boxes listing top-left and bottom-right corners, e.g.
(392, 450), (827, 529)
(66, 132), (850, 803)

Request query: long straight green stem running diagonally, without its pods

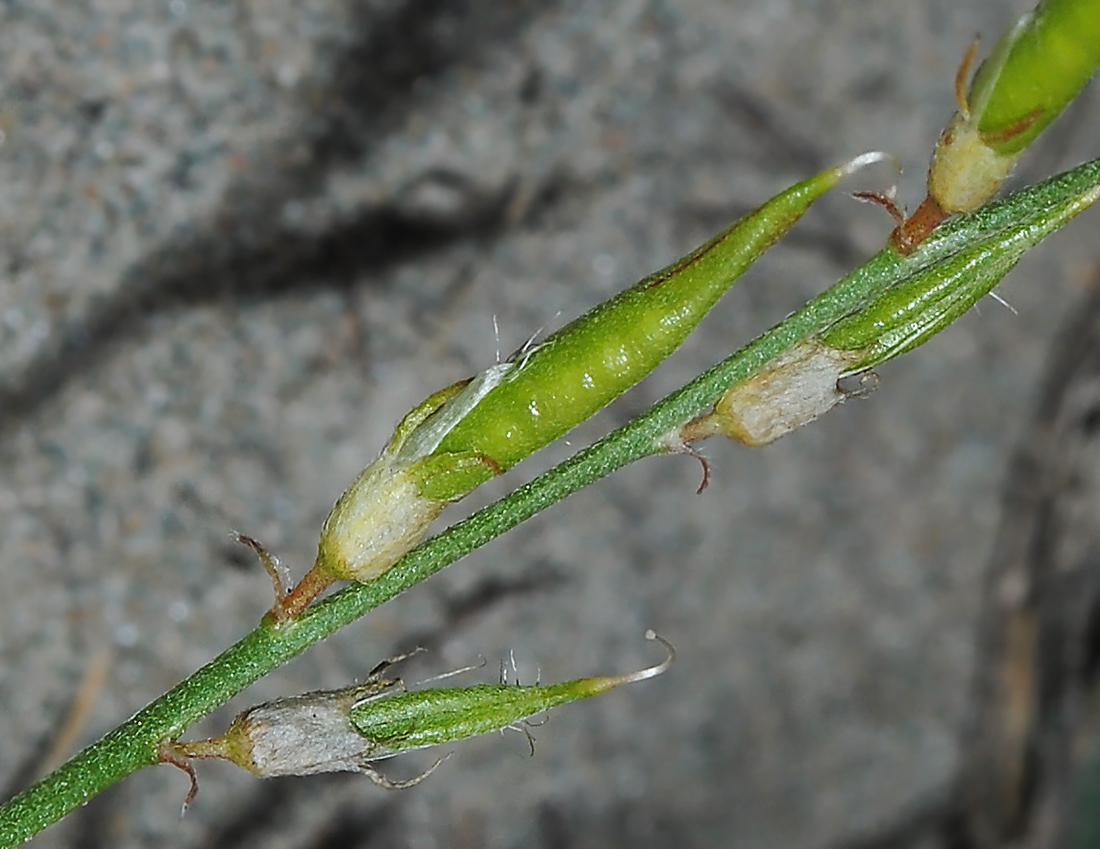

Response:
(0, 159), (1100, 847)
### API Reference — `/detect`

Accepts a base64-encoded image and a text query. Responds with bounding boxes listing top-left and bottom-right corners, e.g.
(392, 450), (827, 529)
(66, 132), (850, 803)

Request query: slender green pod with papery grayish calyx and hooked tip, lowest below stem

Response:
(162, 630), (675, 807)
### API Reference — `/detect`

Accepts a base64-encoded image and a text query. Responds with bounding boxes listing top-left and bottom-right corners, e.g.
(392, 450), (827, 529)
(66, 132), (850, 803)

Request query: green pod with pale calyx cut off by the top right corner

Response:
(928, 0), (1100, 213)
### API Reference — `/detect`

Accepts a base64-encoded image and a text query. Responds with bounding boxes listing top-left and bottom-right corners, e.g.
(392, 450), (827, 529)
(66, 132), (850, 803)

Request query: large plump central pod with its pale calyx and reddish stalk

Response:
(273, 152), (897, 620)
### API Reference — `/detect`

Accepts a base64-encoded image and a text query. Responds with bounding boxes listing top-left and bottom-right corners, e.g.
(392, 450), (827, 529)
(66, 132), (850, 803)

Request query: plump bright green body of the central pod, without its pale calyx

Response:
(421, 153), (887, 483)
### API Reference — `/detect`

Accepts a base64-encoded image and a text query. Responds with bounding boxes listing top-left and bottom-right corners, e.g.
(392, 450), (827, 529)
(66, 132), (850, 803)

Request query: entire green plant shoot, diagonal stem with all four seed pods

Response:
(0, 0), (1100, 835)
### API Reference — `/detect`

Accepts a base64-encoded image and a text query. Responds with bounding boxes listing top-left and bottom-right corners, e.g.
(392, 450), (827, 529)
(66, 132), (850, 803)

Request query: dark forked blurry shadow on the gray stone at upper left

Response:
(0, 0), (556, 435)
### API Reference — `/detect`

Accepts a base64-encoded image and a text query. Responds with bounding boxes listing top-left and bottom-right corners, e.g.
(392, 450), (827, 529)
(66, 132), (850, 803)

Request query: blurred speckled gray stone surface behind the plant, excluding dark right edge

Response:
(0, 0), (1100, 849)
